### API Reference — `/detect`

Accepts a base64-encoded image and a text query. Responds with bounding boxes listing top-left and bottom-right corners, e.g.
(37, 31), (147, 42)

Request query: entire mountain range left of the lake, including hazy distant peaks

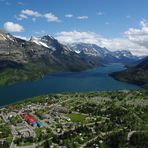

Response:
(0, 31), (142, 84)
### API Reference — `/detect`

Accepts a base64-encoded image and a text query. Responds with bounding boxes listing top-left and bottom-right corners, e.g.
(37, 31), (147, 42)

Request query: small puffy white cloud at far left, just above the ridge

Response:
(4, 22), (24, 32)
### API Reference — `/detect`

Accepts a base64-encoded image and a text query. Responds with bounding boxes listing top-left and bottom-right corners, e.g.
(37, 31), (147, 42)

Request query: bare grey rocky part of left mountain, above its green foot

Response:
(0, 31), (97, 72)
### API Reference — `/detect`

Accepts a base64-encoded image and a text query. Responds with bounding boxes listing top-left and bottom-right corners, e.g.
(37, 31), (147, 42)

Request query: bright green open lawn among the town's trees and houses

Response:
(66, 113), (86, 123)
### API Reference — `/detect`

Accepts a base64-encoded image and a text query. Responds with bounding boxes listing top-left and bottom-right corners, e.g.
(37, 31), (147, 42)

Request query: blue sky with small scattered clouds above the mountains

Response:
(0, 0), (148, 54)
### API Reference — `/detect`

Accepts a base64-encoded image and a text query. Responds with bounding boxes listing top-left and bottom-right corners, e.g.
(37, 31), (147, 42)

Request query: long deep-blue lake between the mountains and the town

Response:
(0, 63), (140, 106)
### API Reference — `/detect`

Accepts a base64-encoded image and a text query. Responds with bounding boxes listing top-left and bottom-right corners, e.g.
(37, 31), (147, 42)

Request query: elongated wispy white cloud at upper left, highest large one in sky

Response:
(16, 9), (60, 22)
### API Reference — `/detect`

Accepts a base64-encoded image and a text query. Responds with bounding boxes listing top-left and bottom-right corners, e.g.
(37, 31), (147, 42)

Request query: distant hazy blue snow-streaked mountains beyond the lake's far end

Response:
(68, 43), (139, 63)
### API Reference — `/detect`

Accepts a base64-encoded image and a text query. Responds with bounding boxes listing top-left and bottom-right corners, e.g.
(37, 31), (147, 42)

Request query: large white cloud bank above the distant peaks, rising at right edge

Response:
(56, 19), (148, 55)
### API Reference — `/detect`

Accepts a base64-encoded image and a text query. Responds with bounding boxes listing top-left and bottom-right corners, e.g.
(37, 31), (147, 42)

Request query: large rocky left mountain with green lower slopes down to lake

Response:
(0, 31), (98, 84)
